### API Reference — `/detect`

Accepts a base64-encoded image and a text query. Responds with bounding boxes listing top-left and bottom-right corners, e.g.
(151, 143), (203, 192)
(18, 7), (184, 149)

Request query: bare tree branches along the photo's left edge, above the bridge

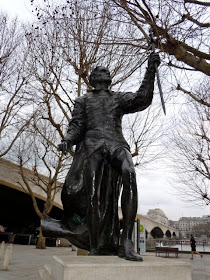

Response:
(0, 12), (30, 156)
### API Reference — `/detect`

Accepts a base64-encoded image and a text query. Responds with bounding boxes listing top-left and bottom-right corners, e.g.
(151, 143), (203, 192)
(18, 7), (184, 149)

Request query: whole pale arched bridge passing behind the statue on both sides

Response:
(0, 158), (178, 239)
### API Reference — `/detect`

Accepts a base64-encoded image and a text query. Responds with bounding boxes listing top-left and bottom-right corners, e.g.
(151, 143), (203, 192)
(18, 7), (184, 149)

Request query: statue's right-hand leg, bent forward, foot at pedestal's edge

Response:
(111, 148), (142, 261)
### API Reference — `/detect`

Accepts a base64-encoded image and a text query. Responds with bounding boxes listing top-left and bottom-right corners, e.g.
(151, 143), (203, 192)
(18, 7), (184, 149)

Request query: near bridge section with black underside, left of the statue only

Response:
(0, 158), (63, 233)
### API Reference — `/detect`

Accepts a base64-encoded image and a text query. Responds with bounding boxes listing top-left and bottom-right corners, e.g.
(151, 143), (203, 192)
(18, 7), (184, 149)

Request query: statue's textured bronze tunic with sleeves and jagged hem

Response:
(65, 66), (154, 155)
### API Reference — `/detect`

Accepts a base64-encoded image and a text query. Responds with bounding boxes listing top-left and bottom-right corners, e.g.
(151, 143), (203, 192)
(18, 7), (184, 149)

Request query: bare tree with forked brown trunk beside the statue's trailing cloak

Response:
(14, 125), (66, 249)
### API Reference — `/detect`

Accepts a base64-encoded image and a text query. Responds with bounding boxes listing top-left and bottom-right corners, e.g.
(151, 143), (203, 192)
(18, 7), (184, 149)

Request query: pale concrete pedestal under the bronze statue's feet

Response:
(40, 256), (192, 280)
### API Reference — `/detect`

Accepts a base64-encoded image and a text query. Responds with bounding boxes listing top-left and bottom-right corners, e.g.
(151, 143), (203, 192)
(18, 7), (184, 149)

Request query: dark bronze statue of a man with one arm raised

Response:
(42, 53), (160, 261)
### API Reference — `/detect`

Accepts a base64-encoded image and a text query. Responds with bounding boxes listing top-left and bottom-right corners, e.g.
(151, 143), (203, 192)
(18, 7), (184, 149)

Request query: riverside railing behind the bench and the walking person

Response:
(146, 239), (210, 253)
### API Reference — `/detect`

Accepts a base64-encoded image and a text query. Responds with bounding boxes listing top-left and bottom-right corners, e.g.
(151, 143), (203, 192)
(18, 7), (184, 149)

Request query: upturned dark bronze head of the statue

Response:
(89, 66), (112, 88)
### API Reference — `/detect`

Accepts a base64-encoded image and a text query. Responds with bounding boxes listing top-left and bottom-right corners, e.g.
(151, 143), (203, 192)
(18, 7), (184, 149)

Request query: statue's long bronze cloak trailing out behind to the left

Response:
(41, 142), (122, 255)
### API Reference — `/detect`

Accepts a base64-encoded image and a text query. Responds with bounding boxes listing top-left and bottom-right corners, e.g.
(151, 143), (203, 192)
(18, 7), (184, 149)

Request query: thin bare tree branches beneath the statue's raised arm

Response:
(123, 104), (168, 167)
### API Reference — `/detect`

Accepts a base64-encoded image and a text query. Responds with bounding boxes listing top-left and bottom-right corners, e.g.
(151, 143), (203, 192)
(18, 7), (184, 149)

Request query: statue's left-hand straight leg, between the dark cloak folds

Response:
(83, 152), (104, 256)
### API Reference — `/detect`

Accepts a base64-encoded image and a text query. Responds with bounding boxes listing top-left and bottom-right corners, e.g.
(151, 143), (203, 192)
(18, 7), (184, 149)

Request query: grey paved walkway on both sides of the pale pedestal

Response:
(0, 244), (210, 280)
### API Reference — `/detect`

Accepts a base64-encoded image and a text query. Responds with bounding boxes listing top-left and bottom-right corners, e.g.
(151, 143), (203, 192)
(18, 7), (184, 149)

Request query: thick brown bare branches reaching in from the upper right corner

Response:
(110, 0), (210, 75)
